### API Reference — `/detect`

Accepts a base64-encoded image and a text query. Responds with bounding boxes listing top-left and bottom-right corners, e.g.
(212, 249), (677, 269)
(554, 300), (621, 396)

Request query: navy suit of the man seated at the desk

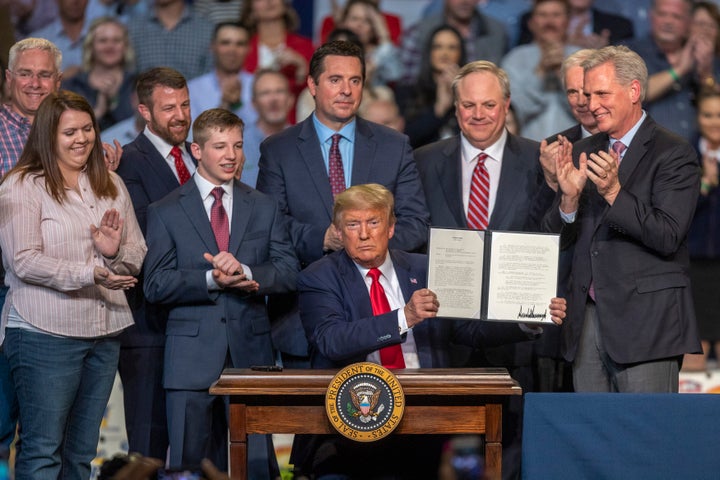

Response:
(292, 250), (530, 479)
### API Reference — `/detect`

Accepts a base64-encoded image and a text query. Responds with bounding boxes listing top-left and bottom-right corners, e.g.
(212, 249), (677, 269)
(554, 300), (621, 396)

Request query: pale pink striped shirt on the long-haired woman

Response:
(0, 172), (147, 342)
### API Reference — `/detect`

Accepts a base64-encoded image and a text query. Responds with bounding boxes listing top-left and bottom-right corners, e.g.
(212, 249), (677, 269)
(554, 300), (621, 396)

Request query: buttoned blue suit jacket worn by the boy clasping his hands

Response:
(144, 179), (298, 390)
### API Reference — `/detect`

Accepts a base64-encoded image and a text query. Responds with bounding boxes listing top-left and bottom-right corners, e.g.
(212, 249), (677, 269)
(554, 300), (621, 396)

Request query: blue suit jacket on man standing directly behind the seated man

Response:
(257, 116), (428, 265)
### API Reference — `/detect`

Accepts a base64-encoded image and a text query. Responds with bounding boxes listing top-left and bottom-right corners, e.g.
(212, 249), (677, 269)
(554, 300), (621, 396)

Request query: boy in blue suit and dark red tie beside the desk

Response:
(144, 108), (298, 472)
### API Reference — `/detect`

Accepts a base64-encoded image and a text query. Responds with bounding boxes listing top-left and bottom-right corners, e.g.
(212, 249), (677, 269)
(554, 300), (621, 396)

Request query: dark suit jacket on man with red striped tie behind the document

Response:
(415, 134), (554, 367)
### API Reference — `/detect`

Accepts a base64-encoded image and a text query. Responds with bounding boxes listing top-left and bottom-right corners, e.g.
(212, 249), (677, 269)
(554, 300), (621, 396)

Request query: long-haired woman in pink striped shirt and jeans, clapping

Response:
(0, 90), (146, 480)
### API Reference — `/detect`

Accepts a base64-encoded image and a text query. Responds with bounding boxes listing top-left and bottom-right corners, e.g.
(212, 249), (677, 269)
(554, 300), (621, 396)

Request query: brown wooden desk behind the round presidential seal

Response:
(210, 368), (522, 480)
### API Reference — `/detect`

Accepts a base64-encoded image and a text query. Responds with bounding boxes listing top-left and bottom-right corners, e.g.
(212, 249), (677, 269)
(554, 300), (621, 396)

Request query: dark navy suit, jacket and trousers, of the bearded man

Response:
(117, 132), (195, 458)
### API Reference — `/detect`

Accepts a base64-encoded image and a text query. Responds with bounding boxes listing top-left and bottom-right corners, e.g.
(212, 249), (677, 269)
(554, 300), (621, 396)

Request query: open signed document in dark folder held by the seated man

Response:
(428, 228), (560, 323)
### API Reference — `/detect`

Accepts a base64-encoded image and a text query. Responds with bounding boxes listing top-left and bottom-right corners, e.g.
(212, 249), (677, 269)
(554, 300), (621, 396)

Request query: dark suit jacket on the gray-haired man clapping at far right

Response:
(543, 116), (700, 363)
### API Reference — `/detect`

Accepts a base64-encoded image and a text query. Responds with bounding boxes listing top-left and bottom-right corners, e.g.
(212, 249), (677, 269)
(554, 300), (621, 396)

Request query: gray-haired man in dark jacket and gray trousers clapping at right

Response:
(543, 47), (701, 392)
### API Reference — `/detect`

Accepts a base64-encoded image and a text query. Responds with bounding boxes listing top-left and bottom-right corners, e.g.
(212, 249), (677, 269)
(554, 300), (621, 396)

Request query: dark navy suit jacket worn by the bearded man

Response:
(117, 132), (194, 347)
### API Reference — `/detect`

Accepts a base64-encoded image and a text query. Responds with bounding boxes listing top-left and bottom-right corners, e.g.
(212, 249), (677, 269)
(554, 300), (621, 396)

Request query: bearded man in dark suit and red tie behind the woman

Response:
(117, 67), (196, 458)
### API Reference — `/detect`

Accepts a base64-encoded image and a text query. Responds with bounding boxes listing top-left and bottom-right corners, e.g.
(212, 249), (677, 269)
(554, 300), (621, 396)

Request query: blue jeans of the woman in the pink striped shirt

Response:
(4, 328), (120, 480)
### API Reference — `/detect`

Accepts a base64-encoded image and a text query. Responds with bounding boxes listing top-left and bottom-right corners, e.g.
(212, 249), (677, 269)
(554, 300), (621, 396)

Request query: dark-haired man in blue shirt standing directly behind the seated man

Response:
(257, 41), (428, 366)
